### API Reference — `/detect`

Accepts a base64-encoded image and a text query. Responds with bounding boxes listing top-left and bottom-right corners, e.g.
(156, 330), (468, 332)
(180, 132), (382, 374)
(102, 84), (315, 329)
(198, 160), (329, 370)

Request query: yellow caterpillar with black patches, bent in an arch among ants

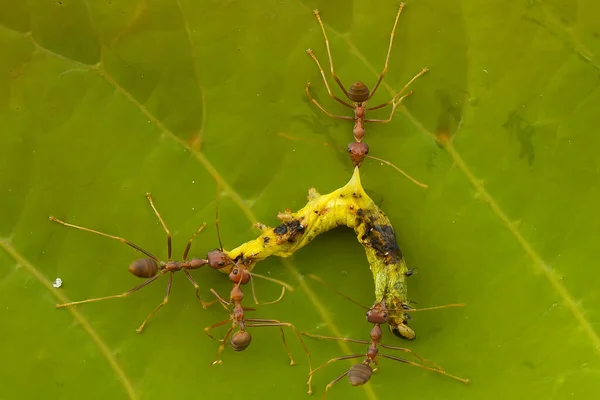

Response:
(223, 167), (415, 339)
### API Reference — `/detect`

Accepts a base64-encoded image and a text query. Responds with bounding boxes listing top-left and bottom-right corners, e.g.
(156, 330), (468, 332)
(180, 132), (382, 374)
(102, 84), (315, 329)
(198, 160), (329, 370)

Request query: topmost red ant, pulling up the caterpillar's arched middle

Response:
(306, 3), (428, 167)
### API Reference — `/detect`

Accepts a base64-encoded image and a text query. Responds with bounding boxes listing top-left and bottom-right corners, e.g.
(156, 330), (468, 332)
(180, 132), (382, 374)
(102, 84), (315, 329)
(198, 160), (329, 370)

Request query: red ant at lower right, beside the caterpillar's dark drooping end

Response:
(302, 274), (470, 400)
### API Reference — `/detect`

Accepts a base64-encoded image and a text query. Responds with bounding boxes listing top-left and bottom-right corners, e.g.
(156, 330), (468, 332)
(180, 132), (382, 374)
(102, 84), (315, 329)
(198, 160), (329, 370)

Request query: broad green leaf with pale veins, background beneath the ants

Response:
(0, 0), (600, 399)
